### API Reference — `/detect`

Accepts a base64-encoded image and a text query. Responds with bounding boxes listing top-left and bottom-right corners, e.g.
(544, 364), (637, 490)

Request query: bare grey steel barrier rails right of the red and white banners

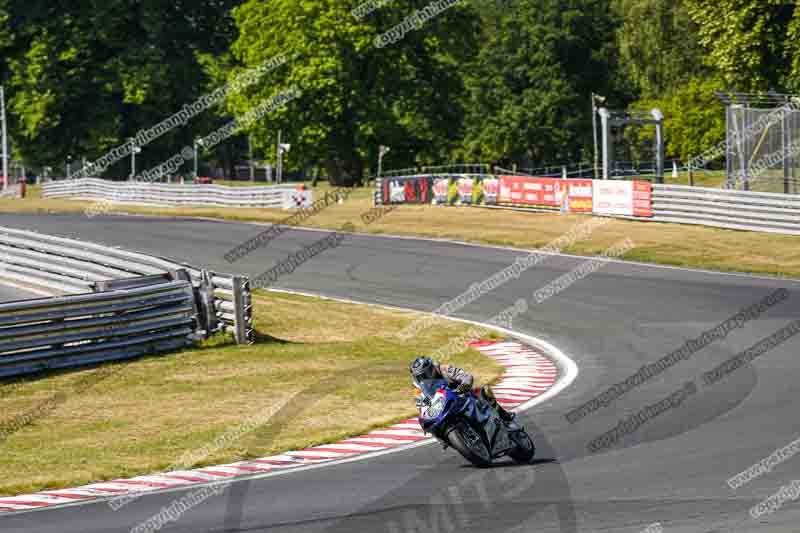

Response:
(653, 185), (800, 235)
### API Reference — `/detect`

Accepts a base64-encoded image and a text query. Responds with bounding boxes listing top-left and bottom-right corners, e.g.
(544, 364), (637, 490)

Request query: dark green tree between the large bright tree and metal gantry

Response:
(456, 0), (616, 164)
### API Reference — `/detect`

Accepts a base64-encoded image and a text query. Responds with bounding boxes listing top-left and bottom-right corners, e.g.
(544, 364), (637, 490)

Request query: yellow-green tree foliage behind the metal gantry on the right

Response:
(616, 0), (726, 166)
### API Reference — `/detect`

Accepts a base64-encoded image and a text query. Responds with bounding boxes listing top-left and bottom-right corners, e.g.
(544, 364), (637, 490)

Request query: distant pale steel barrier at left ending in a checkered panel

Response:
(42, 178), (312, 208)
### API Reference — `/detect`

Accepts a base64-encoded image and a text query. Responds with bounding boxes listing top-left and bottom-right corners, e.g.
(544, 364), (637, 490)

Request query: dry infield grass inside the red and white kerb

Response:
(0, 291), (502, 496)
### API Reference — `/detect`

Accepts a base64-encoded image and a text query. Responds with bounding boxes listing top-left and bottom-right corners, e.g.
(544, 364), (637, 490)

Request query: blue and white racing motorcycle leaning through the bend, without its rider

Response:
(415, 379), (536, 467)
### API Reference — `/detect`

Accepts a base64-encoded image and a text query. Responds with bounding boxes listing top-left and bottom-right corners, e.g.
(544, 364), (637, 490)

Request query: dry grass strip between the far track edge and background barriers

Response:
(0, 184), (800, 277)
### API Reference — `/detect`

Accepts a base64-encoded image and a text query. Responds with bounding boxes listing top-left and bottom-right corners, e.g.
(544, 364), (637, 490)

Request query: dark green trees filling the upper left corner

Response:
(0, 0), (238, 170)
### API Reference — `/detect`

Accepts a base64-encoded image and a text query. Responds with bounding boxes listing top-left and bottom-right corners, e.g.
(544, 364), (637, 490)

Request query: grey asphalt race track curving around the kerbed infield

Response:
(0, 215), (800, 533)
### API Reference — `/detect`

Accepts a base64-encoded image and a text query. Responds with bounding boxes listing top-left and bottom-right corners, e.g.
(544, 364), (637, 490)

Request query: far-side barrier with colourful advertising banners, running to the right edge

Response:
(375, 174), (800, 235)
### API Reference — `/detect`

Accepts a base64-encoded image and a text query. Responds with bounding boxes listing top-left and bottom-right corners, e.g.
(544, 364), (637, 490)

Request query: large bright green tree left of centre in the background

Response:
(225, 0), (477, 185)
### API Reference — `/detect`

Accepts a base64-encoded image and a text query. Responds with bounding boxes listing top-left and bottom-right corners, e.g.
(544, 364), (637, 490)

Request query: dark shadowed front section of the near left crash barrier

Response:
(0, 281), (197, 378)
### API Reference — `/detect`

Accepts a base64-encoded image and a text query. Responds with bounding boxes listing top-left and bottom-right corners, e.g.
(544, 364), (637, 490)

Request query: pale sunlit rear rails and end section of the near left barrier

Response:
(0, 228), (254, 344)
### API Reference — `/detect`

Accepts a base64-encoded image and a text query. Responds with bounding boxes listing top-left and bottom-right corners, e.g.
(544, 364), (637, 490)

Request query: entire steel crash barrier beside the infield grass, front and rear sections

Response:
(0, 228), (255, 377)
